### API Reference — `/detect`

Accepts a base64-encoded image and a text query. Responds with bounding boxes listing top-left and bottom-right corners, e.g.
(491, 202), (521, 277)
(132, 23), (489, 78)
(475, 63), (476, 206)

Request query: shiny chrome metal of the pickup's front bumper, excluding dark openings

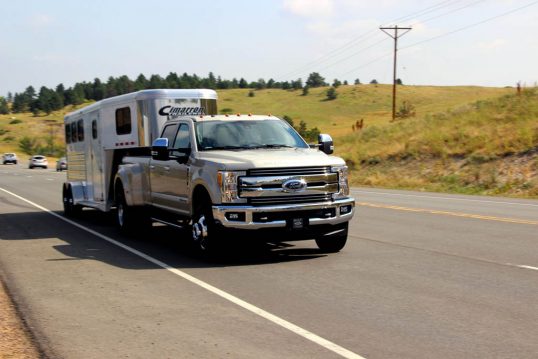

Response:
(213, 198), (355, 229)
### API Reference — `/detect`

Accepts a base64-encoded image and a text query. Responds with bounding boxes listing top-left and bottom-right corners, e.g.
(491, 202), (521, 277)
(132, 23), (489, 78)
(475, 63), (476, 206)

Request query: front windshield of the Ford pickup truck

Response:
(196, 119), (309, 151)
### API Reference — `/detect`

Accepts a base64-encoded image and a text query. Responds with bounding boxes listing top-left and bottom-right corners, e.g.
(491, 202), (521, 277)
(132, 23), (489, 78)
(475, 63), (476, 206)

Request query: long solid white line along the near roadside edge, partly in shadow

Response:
(0, 187), (364, 359)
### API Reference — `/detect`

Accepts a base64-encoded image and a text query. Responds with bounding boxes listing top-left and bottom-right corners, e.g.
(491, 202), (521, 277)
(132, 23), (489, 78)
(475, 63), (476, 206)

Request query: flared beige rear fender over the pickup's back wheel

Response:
(114, 163), (148, 206)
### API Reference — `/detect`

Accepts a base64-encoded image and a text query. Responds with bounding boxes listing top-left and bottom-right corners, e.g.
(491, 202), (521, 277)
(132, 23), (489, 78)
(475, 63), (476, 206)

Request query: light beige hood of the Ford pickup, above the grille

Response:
(197, 148), (345, 171)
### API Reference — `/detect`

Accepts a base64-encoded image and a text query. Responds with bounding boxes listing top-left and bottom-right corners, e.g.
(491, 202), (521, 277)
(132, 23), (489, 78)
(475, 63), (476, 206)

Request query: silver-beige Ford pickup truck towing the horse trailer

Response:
(114, 115), (355, 252)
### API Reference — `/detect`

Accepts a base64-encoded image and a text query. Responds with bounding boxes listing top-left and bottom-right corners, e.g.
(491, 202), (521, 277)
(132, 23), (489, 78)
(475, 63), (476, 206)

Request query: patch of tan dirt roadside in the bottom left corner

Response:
(0, 281), (40, 359)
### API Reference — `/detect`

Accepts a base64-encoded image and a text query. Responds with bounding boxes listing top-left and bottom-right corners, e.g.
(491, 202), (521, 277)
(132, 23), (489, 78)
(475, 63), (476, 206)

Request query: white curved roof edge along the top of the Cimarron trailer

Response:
(62, 89), (217, 117)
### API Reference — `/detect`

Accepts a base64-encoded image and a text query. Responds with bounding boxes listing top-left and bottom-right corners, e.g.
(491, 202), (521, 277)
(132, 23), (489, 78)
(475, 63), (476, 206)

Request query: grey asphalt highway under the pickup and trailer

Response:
(0, 165), (538, 358)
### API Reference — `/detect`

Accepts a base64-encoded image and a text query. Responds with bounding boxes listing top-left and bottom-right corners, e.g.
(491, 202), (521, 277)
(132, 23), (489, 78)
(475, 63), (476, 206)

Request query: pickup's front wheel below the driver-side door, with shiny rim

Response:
(192, 198), (215, 253)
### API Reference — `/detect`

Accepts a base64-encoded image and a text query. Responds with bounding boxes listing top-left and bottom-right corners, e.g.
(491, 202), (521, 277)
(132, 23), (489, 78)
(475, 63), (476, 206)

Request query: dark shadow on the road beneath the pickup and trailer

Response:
(0, 210), (325, 269)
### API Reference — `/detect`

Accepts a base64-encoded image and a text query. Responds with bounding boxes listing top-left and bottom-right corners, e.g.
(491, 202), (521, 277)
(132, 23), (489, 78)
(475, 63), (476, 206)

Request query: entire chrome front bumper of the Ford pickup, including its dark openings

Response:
(213, 198), (355, 230)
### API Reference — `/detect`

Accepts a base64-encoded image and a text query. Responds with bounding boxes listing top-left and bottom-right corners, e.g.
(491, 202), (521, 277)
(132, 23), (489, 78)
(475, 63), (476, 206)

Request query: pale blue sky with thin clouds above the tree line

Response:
(0, 0), (538, 96)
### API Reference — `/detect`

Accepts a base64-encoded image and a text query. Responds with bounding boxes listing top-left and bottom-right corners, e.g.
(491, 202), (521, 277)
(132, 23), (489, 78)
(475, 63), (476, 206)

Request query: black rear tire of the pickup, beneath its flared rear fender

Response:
(116, 184), (151, 236)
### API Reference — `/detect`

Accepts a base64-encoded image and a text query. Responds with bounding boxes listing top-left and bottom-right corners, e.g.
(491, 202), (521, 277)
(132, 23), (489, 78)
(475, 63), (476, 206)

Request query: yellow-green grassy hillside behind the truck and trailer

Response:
(0, 85), (538, 197)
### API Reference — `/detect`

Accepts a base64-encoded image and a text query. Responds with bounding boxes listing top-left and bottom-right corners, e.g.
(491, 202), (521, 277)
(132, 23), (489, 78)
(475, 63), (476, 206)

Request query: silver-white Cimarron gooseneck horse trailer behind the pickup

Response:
(63, 89), (217, 214)
